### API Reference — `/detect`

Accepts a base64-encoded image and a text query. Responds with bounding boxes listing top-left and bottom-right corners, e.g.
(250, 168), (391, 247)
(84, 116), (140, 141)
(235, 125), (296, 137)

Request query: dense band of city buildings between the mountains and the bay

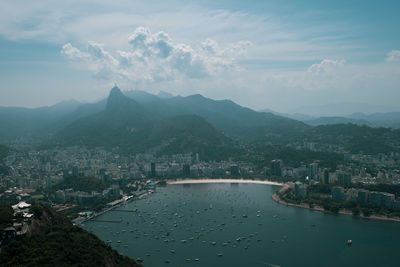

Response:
(0, 139), (400, 227)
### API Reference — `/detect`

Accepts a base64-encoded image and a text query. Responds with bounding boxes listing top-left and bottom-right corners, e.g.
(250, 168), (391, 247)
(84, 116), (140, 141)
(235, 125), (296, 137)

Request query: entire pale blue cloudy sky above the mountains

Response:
(0, 0), (400, 112)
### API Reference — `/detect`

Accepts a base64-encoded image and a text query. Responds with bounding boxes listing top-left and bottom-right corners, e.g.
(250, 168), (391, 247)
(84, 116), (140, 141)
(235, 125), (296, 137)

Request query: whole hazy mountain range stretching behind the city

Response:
(0, 87), (398, 160)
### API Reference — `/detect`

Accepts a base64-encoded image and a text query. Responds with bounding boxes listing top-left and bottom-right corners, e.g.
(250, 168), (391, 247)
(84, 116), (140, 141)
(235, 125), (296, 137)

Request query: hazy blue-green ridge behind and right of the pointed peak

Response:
(126, 91), (308, 140)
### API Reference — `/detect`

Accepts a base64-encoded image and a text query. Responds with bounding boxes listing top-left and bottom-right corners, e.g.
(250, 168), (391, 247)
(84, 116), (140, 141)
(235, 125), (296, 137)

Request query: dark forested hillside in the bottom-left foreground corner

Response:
(0, 205), (141, 267)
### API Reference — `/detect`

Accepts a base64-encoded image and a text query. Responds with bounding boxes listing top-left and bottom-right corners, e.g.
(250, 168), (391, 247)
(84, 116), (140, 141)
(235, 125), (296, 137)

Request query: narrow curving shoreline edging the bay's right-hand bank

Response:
(271, 189), (400, 225)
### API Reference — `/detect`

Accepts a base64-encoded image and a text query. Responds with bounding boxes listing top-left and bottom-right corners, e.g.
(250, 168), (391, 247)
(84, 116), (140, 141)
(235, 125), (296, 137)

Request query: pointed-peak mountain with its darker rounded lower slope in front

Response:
(55, 87), (234, 159)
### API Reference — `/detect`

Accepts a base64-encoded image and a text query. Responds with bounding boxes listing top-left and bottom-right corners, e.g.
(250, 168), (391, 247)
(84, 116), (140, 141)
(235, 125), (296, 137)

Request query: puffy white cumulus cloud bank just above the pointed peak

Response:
(61, 27), (251, 82)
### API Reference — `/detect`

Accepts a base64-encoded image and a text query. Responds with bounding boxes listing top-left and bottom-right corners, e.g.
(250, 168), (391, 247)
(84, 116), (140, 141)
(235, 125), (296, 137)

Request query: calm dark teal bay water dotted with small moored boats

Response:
(84, 184), (400, 267)
